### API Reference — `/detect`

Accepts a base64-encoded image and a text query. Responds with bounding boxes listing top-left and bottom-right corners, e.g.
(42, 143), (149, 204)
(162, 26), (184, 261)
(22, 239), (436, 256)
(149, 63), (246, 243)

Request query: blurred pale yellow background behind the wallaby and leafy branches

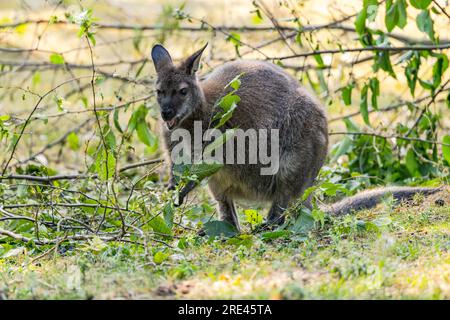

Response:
(0, 0), (450, 181)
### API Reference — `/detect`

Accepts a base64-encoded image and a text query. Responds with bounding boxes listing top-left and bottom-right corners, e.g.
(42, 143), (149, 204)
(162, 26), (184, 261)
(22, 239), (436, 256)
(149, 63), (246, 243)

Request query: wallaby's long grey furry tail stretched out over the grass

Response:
(321, 187), (443, 216)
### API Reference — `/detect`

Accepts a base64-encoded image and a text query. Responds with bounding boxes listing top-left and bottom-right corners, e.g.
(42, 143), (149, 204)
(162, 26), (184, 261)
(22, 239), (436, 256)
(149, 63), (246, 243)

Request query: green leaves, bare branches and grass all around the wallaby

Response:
(0, 0), (450, 299)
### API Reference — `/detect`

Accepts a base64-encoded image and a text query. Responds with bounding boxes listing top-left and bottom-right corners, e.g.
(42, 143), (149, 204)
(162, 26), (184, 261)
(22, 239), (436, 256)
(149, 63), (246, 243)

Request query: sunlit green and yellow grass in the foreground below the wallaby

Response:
(0, 189), (450, 299)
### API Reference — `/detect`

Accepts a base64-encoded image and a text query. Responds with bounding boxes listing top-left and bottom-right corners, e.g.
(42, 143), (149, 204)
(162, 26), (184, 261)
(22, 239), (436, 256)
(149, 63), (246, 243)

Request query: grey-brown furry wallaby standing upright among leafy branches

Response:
(151, 45), (437, 230)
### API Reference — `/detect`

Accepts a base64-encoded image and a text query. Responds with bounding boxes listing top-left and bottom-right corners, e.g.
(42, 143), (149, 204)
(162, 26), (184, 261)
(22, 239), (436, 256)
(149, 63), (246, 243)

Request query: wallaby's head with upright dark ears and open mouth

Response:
(152, 44), (207, 130)
